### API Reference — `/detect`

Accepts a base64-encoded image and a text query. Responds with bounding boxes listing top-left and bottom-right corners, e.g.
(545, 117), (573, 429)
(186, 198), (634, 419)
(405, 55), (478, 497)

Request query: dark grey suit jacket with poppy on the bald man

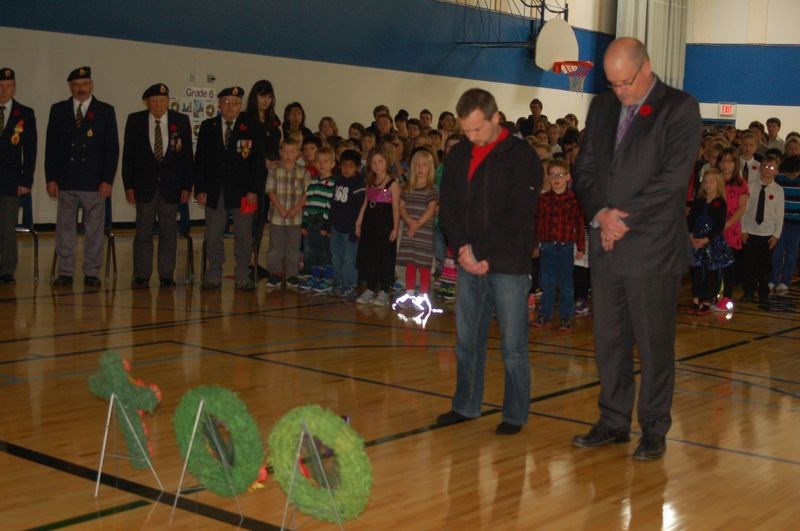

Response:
(572, 80), (701, 277)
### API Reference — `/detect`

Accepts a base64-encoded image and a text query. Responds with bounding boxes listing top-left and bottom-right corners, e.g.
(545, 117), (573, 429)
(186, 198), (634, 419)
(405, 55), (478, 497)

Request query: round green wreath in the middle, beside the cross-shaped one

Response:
(172, 386), (264, 496)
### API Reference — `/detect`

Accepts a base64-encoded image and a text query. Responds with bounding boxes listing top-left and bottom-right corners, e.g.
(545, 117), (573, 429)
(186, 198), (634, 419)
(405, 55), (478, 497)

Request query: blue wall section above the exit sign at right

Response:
(684, 44), (800, 106)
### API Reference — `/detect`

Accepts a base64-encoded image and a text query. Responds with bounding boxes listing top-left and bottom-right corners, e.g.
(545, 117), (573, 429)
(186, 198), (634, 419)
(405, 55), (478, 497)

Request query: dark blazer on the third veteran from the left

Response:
(122, 110), (194, 204)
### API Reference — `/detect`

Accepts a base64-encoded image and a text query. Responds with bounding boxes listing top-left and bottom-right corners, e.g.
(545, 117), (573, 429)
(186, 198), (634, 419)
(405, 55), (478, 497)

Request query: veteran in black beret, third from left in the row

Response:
(122, 83), (194, 289)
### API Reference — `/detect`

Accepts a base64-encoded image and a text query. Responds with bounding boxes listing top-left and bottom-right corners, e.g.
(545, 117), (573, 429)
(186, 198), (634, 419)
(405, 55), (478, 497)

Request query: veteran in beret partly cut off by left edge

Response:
(0, 67), (36, 285)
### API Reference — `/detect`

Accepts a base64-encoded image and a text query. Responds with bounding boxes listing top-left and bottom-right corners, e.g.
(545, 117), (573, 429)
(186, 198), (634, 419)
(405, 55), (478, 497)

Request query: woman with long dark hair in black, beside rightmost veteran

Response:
(245, 79), (281, 278)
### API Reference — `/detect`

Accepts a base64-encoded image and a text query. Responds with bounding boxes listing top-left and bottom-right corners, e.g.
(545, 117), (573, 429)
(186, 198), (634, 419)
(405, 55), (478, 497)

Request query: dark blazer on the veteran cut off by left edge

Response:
(0, 99), (36, 196)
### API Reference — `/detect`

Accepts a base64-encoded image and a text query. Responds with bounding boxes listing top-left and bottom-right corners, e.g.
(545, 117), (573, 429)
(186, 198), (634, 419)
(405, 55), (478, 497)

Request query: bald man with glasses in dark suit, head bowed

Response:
(572, 38), (701, 460)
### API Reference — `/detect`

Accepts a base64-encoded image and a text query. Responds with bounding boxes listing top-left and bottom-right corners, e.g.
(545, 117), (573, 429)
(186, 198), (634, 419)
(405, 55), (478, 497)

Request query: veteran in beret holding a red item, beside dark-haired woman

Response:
(194, 87), (266, 291)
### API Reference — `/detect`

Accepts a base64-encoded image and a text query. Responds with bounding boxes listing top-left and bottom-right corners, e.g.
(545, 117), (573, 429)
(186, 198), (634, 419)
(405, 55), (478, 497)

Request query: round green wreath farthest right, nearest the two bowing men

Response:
(269, 405), (372, 522)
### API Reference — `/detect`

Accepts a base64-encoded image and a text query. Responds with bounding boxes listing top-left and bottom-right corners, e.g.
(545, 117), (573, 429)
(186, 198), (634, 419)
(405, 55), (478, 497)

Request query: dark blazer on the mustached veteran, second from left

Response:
(44, 97), (119, 192)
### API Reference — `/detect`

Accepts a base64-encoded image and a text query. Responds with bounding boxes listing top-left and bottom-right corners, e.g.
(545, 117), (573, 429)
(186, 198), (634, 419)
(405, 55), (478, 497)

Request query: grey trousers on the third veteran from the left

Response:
(133, 192), (178, 280)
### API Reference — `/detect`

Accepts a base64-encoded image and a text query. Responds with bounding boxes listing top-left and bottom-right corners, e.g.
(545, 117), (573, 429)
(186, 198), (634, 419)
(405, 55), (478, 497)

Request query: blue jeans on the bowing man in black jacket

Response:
(453, 267), (531, 426)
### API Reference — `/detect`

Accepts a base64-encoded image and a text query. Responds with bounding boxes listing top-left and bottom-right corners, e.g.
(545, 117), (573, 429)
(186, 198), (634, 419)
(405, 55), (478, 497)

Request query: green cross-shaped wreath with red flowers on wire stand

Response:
(89, 351), (161, 469)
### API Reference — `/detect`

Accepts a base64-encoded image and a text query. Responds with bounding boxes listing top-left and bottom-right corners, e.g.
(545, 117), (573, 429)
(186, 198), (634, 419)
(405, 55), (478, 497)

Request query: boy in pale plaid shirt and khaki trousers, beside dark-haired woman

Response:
(267, 140), (311, 288)
